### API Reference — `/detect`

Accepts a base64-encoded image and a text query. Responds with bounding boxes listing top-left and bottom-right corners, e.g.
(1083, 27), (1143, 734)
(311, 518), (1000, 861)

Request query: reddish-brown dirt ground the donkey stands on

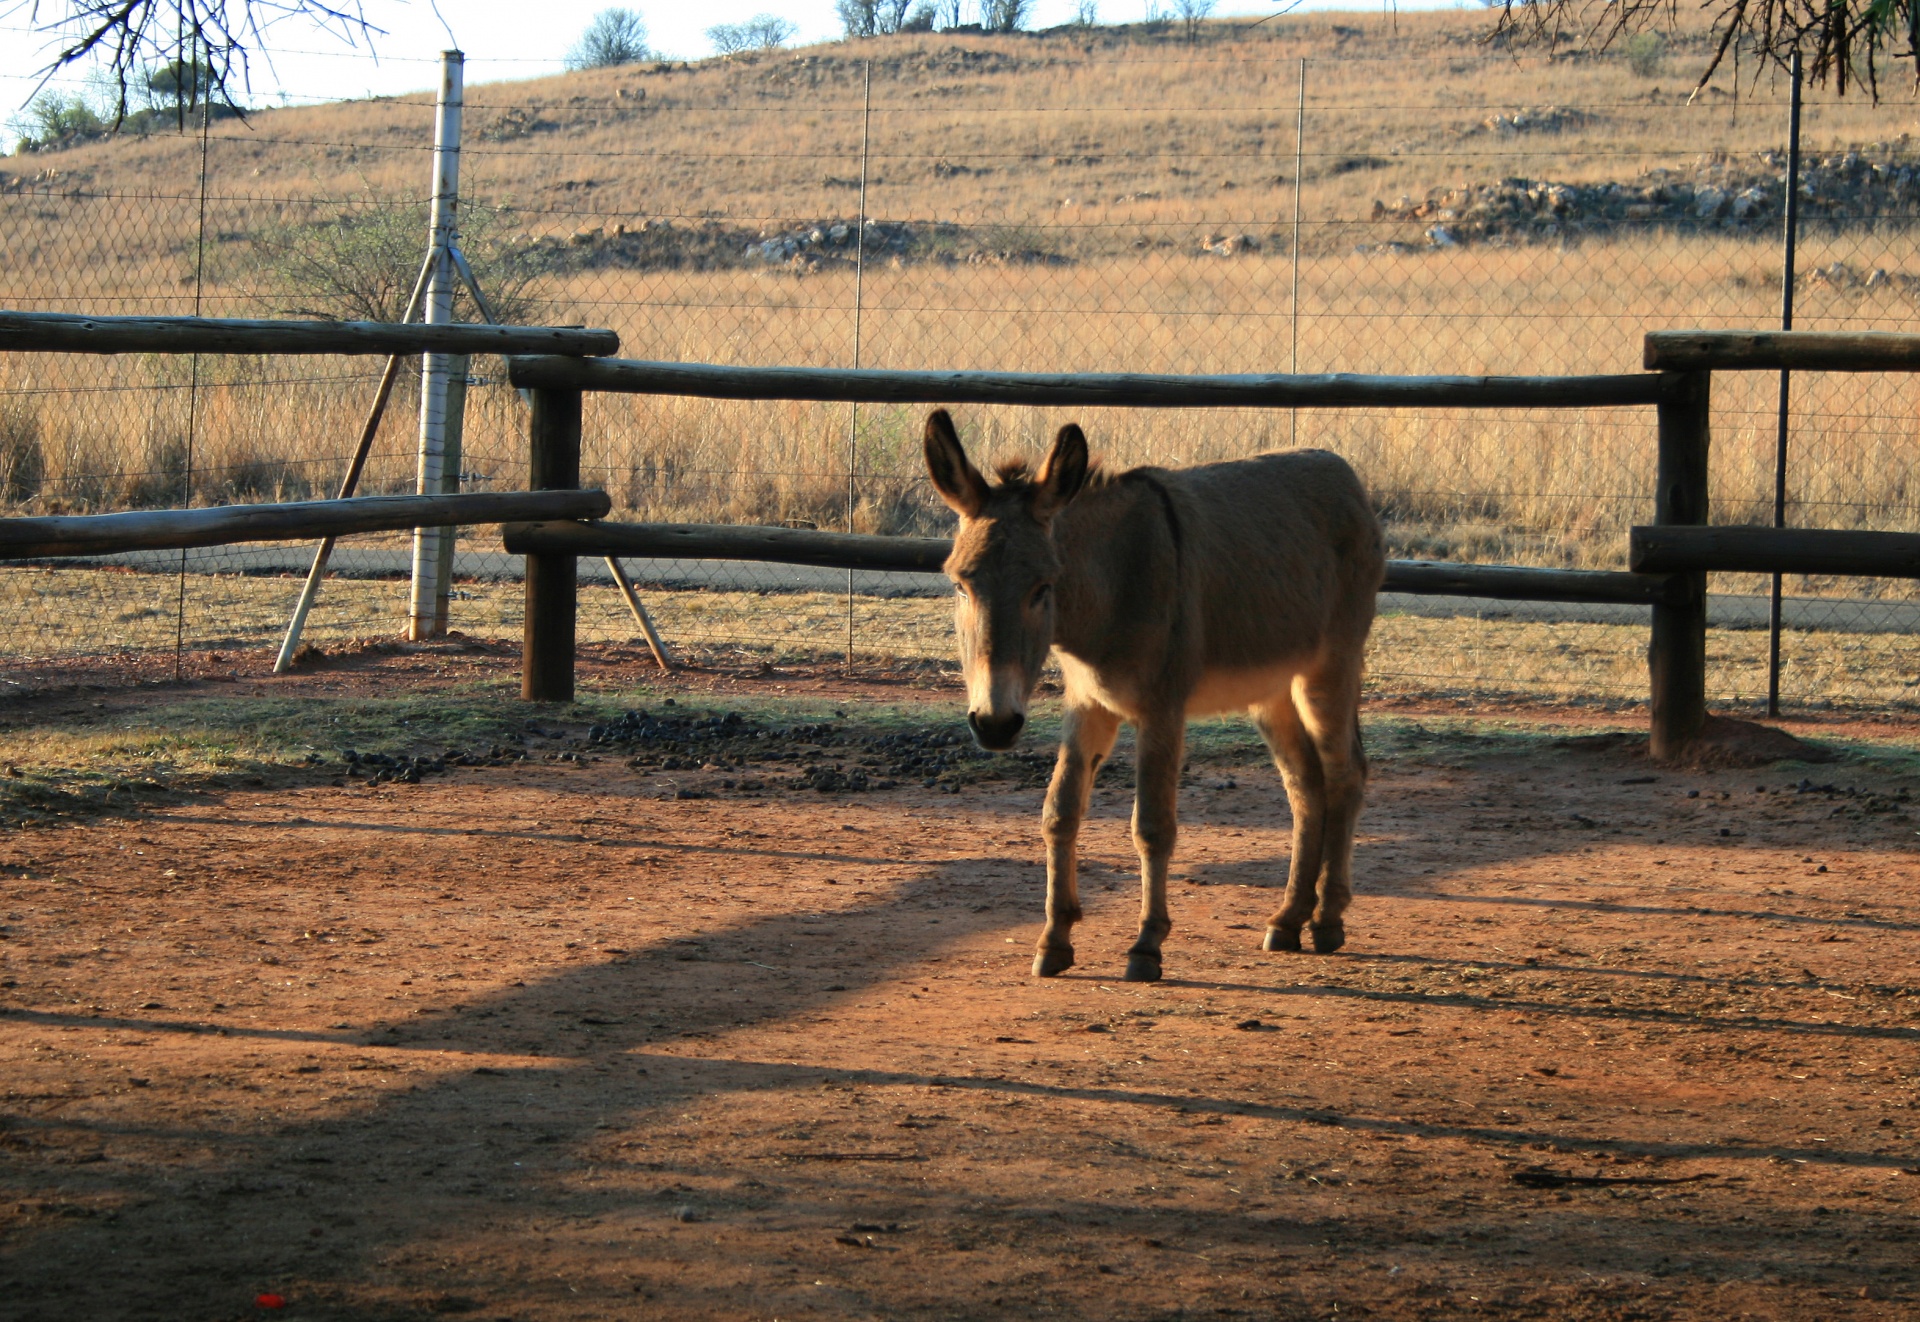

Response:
(0, 656), (1920, 1320)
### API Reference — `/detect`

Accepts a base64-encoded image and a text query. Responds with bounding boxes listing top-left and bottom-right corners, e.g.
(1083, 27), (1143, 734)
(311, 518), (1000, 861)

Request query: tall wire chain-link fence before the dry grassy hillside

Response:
(0, 15), (1920, 706)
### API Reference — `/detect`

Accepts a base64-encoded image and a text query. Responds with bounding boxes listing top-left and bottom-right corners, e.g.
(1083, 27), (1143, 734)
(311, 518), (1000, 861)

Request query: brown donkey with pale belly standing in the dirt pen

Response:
(925, 411), (1386, 982)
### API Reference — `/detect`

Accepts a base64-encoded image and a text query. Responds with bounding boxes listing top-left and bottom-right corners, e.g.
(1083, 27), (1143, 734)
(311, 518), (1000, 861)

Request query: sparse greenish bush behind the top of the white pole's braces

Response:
(253, 192), (547, 324)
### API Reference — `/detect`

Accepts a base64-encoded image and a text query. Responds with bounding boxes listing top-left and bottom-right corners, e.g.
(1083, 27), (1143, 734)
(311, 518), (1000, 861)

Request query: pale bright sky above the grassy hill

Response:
(0, 0), (1457, 114)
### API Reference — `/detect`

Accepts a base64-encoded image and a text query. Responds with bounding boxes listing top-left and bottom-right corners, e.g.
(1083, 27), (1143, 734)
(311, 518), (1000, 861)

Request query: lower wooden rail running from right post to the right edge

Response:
(1628, 526), (1920, 578)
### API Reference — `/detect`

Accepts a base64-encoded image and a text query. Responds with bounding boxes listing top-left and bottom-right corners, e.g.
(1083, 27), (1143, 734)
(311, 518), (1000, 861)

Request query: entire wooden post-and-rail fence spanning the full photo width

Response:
(15, 311), (1920, 758)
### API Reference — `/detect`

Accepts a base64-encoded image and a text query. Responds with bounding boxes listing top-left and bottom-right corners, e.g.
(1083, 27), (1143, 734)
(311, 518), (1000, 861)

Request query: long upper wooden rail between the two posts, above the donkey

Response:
(507, 357), (1684, 409)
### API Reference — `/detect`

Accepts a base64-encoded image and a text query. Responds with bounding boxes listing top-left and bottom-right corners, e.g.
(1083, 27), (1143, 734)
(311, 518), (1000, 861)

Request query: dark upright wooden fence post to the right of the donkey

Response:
(1647, 372), (1713, 762)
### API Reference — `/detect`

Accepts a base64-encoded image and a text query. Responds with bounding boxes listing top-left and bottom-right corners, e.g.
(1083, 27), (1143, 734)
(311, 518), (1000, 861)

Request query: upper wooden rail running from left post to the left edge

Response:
(0, 311), (620, 355)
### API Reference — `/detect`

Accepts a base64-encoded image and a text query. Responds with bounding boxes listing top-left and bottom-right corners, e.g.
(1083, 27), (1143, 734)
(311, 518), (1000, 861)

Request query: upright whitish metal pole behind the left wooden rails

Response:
(407, 50), (467, 641)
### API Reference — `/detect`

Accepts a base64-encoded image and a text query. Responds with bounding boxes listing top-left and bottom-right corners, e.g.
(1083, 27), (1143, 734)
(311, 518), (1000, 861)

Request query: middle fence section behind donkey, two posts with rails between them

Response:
(503, 355), (1711, 758)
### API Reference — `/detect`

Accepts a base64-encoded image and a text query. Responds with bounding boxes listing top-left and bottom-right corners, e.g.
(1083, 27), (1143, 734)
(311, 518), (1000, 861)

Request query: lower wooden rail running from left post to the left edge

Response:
(0, 491), (612, 560)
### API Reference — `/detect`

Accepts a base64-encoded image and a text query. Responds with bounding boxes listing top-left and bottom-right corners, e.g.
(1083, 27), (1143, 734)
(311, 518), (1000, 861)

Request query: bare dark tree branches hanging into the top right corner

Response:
(1498, 0), (1920, 96)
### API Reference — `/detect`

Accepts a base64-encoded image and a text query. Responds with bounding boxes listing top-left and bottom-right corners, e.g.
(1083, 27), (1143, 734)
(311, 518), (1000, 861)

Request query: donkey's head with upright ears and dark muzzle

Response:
(927, 409), (1087, 748)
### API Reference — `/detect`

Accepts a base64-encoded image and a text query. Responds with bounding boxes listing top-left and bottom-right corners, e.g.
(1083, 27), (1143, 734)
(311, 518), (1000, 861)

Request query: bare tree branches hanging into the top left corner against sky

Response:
(21, 0), (384, 123)
